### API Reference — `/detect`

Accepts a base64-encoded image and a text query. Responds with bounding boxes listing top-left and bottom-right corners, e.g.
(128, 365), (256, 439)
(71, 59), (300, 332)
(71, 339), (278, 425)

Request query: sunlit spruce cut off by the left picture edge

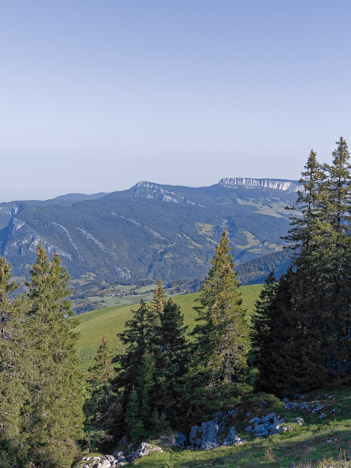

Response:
(0, 258), (32, 468)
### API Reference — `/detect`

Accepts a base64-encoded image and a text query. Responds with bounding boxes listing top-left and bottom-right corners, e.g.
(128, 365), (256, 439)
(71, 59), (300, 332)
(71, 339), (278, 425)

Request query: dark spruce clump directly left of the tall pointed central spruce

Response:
(106, 279), (192, 440)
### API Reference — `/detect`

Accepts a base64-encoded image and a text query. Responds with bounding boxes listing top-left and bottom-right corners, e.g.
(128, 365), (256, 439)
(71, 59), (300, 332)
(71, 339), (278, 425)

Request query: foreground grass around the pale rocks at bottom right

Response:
(135, 389), (351, 468)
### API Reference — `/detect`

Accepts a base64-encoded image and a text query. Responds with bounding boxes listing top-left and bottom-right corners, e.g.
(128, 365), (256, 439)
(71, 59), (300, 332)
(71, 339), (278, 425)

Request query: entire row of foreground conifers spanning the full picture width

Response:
(0, 138), (351, 468)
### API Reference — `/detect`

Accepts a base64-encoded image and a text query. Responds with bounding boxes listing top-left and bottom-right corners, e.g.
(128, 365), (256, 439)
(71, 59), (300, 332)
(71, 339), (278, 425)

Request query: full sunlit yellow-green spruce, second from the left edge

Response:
(26, 244), (84, 468)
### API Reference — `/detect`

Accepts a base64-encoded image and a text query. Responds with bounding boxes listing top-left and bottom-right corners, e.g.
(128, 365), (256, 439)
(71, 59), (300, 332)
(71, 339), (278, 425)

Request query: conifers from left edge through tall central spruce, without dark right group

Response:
(0, 232), (248, 468)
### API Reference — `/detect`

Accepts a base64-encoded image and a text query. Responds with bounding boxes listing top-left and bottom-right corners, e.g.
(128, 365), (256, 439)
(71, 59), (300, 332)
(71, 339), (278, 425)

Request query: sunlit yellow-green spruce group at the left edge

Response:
(0, 245), (84, 467)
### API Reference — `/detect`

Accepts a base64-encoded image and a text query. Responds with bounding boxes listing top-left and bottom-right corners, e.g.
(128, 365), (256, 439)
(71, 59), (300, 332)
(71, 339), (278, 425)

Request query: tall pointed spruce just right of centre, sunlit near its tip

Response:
(192, 230), (249, 410)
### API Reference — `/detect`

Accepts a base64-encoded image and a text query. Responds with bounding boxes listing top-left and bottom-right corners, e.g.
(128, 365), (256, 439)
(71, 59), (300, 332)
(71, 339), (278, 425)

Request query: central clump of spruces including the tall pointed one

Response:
(86, 231), (249, 441)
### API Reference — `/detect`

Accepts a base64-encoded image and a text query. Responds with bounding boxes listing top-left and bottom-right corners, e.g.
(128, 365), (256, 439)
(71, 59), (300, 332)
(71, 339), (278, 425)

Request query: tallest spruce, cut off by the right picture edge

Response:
(319, 137), (351, 385)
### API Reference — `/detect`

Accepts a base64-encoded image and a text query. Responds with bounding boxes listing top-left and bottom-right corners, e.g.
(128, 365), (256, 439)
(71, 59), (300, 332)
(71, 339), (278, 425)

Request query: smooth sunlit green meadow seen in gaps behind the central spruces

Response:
(77, 284), (262, 370)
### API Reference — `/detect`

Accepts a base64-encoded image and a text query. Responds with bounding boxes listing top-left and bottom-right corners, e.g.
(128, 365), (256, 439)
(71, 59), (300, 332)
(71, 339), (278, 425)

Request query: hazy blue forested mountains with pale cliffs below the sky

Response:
(0, 178), (299, 283)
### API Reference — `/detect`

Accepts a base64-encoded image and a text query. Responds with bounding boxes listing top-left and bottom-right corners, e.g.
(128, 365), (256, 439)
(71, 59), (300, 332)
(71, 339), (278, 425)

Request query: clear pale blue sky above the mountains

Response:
(0, 0), (351, 201)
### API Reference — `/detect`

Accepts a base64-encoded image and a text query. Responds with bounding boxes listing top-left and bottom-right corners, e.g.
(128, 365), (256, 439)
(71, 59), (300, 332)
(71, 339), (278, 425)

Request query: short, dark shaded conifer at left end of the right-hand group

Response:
(252, 267), (306, 396)
